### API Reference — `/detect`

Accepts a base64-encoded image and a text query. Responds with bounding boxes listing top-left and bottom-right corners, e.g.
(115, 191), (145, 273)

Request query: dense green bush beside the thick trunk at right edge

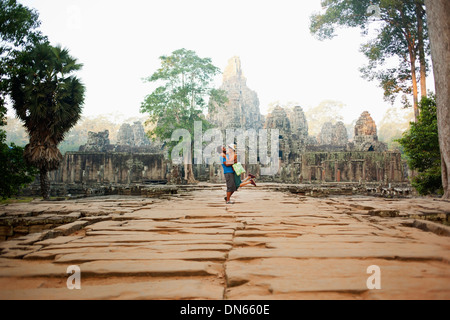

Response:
(398, 96), (442, 194)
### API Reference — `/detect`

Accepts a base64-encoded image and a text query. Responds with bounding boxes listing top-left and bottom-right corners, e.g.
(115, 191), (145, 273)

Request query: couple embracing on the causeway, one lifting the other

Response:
(217, 144), (256, 204)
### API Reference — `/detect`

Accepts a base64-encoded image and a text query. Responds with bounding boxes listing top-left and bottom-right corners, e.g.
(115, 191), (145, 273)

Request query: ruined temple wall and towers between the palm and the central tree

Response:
(52, 122), (166, 184)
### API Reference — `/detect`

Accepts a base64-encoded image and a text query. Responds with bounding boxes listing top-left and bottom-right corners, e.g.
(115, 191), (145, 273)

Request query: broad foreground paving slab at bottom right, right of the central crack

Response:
(227, 258), (450, 299)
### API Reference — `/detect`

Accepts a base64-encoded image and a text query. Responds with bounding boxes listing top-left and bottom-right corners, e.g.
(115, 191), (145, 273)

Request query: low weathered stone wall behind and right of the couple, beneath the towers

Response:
(188, 151), (408, 185)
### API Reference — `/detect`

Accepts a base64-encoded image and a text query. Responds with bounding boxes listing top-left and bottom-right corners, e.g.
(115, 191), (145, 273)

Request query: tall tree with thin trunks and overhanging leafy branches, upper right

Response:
(310, 0), (429, 120)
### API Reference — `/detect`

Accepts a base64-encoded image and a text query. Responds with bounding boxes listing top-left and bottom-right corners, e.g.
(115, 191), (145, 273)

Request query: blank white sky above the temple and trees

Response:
(14, 0), (431, 123)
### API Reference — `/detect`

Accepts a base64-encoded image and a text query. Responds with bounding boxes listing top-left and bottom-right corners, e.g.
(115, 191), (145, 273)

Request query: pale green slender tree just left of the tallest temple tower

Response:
(141, 49), (226, 183)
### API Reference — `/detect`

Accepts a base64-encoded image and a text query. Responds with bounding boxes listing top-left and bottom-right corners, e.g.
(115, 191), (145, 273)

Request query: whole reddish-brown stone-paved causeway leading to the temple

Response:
(0, 185), (450, 300)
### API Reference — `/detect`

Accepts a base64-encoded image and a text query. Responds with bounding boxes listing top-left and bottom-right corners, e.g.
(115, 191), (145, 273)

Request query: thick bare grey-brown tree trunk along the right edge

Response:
(425, 0), (450, 199)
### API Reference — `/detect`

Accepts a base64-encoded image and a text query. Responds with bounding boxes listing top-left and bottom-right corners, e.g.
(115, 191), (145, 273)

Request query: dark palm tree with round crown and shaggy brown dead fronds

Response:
(10, 43), (85, 199)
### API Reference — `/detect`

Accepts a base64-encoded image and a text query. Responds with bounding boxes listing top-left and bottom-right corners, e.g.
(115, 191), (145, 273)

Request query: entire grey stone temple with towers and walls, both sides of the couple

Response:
(46, 57), (408, 195)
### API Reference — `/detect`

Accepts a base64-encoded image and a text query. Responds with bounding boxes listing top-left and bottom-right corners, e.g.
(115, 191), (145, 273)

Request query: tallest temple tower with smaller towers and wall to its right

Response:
(206, 57), (406, 183)
